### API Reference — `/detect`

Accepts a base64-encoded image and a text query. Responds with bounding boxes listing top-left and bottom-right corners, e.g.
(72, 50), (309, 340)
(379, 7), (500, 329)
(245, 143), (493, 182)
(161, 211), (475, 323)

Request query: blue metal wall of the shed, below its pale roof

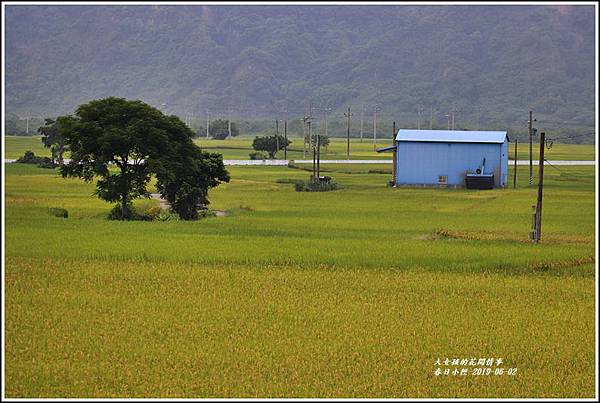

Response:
(396, 139), (508, 187)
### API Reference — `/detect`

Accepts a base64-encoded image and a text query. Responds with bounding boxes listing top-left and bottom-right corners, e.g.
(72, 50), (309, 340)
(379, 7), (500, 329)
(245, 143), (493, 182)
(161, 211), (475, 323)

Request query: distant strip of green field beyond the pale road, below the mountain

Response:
(5, 136), (595, 160)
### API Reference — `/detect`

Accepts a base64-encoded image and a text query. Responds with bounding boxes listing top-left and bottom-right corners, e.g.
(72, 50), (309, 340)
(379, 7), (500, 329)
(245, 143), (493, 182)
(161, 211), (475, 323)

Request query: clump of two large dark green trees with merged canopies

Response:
(60, 97), (229, 219)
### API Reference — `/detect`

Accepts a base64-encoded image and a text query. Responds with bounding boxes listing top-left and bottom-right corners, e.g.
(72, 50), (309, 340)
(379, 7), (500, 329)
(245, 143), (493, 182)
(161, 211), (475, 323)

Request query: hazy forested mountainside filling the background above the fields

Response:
(6, 5), (595, 140)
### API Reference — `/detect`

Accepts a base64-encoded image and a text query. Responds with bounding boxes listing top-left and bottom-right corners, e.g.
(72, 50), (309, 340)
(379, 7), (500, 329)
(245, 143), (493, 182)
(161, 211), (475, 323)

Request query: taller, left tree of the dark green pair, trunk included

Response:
(61, 97), (172, 219)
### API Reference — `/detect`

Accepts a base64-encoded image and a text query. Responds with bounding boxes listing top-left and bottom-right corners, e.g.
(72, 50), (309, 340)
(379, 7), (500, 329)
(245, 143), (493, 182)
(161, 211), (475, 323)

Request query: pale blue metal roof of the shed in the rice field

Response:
(396, 129), (507, 143)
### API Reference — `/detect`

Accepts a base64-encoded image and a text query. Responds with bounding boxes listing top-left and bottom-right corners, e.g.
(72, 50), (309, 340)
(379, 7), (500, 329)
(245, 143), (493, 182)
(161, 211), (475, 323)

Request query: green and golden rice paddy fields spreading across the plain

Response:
(4, 137), (596, 398)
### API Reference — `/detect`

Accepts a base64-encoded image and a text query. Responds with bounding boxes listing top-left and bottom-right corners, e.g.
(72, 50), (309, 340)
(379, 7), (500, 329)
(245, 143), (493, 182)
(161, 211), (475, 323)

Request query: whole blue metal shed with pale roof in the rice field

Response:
(382, 129), (509, 187)
